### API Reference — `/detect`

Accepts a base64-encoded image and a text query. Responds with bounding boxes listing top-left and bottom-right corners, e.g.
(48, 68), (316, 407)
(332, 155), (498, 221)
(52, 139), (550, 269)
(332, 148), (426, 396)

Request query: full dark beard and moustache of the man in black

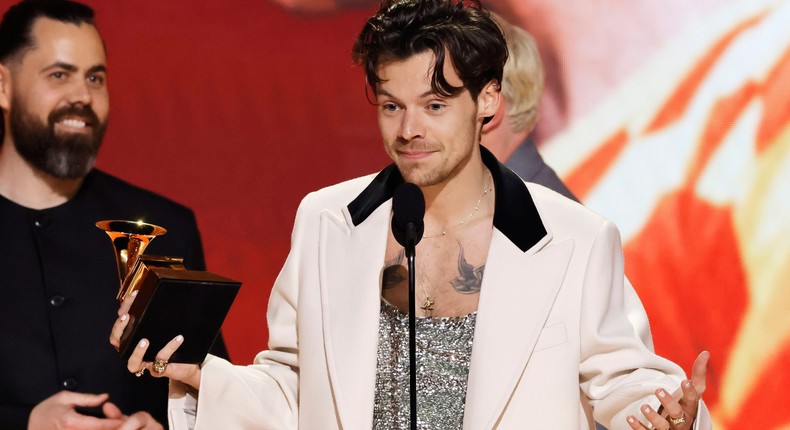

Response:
(7, 100), (107, 179)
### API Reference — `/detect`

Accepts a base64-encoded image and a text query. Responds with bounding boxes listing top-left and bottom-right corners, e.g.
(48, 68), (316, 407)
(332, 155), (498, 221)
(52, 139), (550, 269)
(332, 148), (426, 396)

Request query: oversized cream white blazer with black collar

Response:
(170, 149), (711, 430)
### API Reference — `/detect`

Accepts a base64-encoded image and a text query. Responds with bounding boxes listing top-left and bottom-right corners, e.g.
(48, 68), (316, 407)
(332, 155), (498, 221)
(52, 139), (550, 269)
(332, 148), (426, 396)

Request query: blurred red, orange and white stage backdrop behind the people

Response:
(0, 0), (790, 429)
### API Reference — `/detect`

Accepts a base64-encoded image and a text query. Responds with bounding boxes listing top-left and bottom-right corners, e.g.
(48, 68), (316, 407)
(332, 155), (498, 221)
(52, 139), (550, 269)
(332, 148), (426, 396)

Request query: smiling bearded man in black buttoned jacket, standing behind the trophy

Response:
(0, 0), (226, 429)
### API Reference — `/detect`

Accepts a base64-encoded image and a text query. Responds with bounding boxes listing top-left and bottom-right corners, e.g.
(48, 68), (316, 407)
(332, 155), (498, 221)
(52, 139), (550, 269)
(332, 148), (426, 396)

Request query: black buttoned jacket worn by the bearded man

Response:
(0, 170), (227, 429)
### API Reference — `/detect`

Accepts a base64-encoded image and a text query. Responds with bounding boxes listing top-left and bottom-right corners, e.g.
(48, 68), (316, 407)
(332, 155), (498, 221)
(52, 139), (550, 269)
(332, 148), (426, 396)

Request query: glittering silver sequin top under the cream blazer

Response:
(373, 301), (477, 430)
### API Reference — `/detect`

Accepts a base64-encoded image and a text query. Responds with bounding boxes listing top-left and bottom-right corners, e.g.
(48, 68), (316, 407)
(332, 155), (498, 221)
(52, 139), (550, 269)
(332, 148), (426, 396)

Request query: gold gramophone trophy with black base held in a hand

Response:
(96, 220), (241, 363)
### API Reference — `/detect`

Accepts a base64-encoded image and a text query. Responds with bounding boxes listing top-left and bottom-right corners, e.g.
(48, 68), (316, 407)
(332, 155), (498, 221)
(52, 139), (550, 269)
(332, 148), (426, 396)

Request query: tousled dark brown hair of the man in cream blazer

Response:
(352, 0), (507, 100)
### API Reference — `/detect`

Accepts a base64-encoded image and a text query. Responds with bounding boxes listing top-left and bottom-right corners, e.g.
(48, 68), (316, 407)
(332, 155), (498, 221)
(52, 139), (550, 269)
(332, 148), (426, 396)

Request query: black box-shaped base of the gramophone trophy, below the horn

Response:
(119, 263), (241, 364)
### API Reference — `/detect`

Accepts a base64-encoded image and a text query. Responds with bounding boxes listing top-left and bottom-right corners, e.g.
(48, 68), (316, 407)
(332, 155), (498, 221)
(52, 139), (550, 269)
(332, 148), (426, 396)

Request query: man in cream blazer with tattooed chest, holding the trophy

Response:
(112, 0), (710, 430)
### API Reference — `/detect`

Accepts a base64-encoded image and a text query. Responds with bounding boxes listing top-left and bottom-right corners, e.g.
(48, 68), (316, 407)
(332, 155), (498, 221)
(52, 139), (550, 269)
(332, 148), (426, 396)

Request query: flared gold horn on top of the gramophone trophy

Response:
(96, 220), (167, 300)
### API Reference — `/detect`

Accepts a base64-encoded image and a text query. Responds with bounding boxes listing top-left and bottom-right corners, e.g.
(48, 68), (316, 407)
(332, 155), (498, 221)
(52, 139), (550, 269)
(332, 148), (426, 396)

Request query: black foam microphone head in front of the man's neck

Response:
(392, 182), (425, 247)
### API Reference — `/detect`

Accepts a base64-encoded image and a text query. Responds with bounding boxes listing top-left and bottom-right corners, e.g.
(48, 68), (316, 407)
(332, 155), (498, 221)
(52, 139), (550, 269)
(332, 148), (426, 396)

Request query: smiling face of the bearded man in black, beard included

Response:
(6, 18), (109, 179)
